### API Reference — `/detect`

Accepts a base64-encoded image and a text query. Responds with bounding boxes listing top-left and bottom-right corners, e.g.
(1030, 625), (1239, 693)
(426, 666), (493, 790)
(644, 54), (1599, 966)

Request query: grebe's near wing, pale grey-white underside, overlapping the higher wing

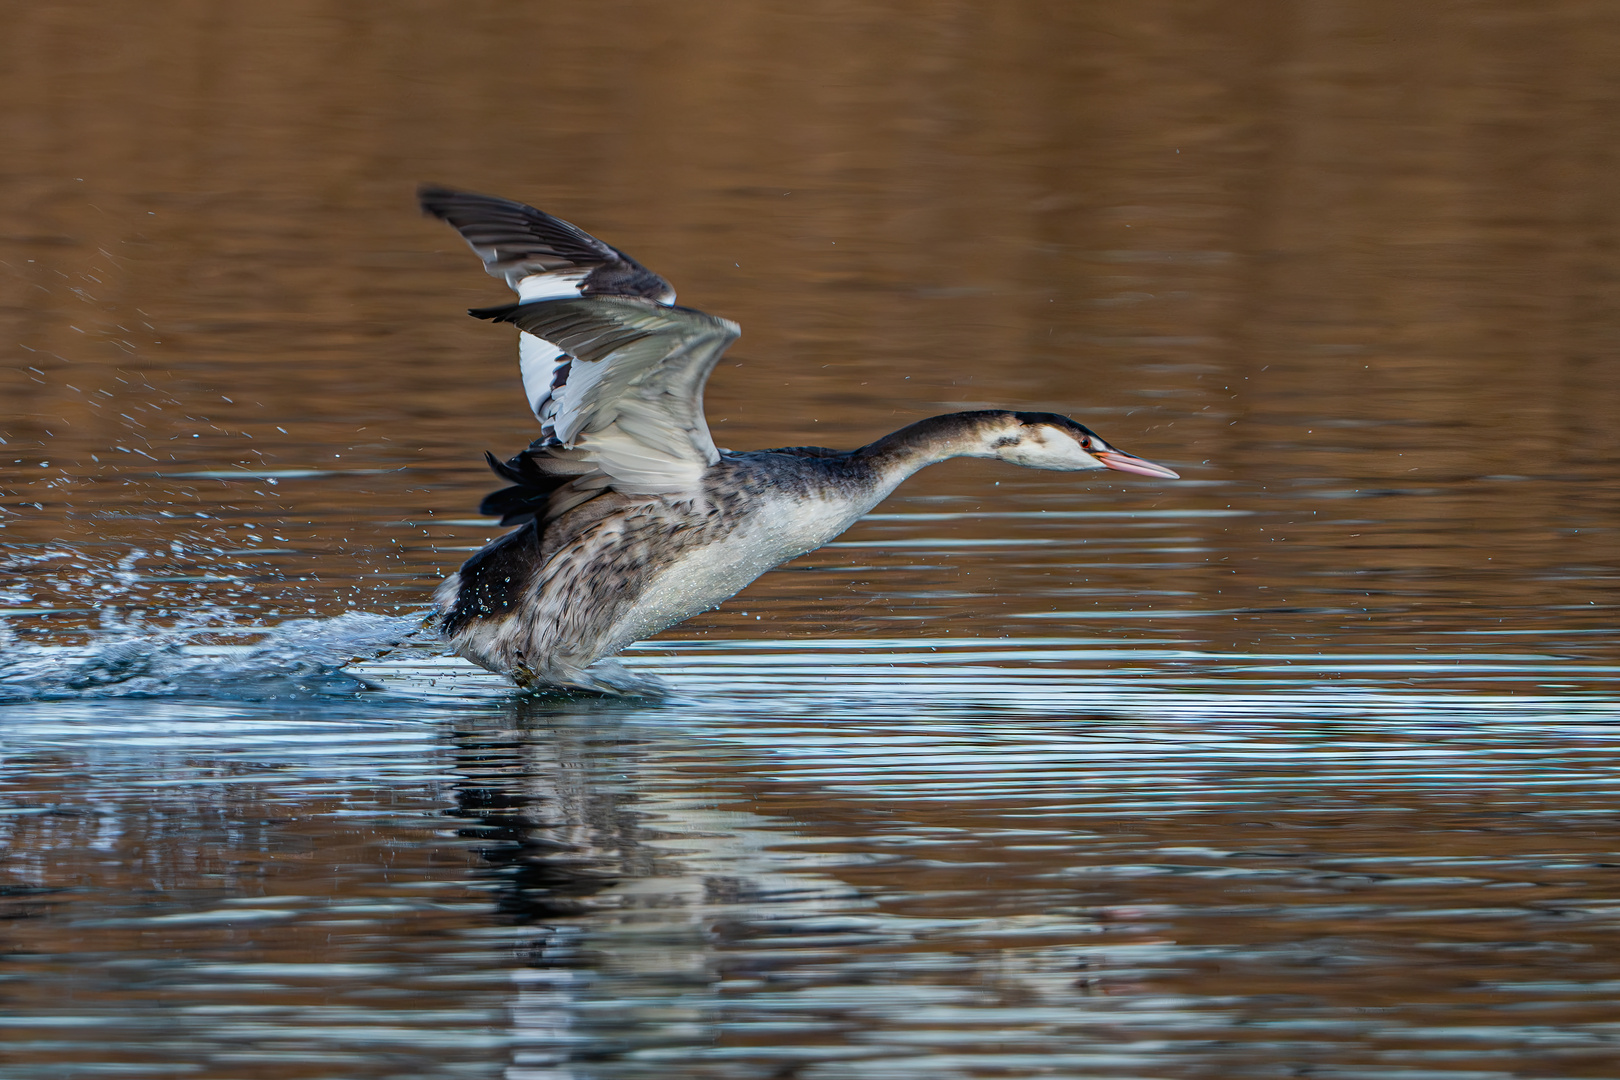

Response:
(471, 296), (740, 495)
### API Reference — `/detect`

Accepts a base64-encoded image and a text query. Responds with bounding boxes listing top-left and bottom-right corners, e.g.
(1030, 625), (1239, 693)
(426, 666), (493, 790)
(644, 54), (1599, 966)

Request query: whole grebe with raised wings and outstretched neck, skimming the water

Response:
(418, 185), (1176, 693)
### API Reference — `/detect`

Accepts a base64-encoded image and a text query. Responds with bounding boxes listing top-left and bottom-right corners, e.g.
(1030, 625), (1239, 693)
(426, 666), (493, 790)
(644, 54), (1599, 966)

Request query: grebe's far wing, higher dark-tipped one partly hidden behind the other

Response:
(416, 185), (676, 436)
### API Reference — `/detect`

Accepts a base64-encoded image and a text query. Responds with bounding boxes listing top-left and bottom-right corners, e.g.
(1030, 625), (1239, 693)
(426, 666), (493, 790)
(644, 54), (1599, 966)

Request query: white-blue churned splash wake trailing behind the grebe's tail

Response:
(0, 612), (439, 704)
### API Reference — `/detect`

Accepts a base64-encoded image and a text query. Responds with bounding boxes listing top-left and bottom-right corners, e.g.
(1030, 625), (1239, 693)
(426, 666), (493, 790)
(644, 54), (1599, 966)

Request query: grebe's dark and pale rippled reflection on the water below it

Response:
(437, 699), (777, 1080)
